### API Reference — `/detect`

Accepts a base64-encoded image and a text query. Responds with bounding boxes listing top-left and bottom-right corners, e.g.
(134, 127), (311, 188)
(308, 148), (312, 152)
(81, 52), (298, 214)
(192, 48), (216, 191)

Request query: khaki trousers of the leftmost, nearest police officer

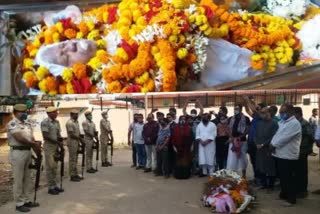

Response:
(10, 150), (31, 206)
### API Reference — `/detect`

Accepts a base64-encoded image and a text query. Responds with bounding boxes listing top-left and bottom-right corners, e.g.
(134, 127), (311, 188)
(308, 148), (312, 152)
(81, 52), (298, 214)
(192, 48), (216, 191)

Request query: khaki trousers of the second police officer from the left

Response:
(44, 143), (58, 189)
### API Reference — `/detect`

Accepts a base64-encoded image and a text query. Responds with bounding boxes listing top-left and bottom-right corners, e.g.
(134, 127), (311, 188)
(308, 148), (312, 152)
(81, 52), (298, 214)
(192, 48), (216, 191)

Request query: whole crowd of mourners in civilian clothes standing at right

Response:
(128, 97), (320, 206)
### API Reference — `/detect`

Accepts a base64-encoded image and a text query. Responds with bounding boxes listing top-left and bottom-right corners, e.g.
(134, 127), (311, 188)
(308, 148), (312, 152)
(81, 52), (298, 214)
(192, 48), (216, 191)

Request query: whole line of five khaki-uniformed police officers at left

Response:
(7, 104), (113, 212)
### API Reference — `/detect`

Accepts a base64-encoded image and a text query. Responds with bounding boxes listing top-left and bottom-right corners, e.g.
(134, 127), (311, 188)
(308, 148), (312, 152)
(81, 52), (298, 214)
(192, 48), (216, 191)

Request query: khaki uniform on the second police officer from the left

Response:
(41, 118), (61, 189)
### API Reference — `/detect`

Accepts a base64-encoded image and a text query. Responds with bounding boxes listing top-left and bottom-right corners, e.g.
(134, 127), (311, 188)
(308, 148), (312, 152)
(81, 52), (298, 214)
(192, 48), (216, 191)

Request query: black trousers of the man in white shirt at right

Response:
(277, 158), (298, 204)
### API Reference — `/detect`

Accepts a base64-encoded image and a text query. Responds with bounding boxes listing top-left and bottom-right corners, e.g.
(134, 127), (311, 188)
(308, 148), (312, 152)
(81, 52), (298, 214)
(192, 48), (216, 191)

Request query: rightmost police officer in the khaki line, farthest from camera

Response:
(100, 111), (112, 167)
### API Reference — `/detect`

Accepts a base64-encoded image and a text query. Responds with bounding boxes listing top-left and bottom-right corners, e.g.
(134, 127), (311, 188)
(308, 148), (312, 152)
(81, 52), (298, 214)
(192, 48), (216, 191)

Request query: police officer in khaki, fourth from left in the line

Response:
(82, 111), (98, 173)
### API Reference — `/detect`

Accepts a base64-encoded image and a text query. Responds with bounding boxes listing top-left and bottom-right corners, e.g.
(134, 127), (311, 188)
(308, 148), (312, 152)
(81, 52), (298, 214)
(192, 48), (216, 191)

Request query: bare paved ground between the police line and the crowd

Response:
(0, 149), (320, 214)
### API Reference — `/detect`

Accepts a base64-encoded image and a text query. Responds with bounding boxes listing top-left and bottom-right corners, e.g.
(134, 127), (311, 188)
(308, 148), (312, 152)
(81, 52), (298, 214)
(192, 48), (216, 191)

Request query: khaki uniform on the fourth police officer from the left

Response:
(82, 120), (96, 170)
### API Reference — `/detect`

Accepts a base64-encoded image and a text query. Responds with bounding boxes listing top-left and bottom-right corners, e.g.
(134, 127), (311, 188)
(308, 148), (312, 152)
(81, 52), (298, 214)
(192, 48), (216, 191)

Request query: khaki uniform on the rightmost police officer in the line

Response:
(100, 119), (111, 163)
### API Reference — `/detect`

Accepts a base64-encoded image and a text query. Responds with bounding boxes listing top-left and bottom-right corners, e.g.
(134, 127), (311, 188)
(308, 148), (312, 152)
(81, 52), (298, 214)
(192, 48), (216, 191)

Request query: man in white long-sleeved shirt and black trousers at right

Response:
(271, 104), (302, 206)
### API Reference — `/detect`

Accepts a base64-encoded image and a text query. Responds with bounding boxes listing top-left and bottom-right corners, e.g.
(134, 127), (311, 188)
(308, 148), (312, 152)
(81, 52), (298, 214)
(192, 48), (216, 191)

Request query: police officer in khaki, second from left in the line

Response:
(41, 106), (63, 195)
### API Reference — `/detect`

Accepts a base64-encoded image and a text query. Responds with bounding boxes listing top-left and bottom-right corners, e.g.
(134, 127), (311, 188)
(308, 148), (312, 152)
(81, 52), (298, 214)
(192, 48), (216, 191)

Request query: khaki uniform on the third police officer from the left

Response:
(66, 119), (80, 176)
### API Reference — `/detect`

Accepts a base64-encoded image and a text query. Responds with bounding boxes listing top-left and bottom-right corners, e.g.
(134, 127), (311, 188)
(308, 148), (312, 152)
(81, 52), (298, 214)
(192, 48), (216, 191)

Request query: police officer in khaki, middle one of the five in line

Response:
(66, 110), (82, 182)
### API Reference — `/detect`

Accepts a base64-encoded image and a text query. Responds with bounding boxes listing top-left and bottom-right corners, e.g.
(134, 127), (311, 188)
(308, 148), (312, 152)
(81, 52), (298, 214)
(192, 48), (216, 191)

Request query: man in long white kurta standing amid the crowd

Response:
(196, 114), (217, 176)
